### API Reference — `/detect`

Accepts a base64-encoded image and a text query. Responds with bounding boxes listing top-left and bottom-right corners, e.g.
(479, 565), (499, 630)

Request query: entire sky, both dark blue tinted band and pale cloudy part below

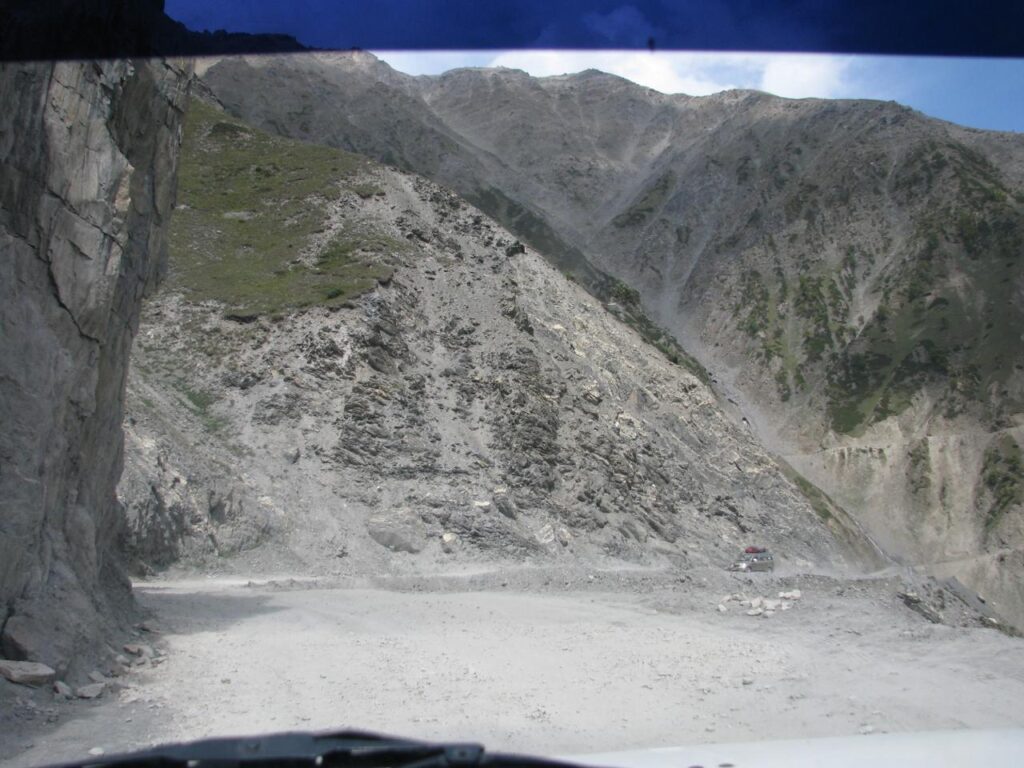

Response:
(166, 0), (1024, 131)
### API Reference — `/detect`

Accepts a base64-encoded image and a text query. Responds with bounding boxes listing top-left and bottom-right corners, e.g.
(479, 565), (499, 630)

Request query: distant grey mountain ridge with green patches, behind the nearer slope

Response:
(199, 53), (1024, 622)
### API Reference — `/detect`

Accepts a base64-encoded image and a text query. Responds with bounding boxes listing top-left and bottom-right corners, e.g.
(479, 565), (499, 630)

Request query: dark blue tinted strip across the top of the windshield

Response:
(166, 0), (1024, 56)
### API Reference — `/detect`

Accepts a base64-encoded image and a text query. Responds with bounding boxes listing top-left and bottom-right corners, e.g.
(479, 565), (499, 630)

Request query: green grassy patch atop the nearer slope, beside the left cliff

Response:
(169, 99), (395, 317)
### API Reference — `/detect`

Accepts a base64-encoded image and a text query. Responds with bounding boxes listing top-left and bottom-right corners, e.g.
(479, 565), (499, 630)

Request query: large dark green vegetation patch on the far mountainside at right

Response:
(827, 142), (1024, 433)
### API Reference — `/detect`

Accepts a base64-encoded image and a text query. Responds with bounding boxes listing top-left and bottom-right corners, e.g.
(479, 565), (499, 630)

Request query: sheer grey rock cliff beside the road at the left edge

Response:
(0, 60), (189, 674)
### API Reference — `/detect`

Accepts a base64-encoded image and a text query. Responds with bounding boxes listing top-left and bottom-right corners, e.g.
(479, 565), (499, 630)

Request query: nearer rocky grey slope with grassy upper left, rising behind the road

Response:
(121, 96), (872, 573)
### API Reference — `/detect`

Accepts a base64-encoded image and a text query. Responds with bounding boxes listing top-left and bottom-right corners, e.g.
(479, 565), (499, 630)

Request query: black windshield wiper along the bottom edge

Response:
(46, 731), (593, 768)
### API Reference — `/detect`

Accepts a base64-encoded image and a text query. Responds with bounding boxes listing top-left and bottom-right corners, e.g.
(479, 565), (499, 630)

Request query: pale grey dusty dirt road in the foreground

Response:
(0, 578), (1024, 768)
